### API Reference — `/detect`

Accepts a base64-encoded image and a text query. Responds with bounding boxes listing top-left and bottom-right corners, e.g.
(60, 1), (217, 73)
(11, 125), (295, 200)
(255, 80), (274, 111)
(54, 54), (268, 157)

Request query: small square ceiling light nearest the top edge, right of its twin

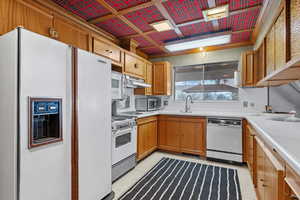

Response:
(202, 4), (229, 21)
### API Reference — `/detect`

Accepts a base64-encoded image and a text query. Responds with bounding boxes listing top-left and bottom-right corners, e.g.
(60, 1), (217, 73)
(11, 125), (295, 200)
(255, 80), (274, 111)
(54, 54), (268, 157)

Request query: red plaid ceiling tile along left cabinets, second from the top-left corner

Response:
(96, 18), (136, 37)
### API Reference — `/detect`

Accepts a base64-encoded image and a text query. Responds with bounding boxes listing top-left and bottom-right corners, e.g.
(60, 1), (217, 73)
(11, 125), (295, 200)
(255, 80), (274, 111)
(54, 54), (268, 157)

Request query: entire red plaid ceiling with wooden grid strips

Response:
(52, 0), (263, 55)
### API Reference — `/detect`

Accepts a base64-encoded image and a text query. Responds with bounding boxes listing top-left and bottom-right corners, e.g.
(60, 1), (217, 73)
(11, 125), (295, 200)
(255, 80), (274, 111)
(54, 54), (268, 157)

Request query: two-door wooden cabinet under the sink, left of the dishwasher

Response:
(158, 115), (206, 156)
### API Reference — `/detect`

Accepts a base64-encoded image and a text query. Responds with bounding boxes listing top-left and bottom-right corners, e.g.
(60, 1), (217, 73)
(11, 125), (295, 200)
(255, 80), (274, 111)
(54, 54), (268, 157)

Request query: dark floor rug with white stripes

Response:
(119, 158), (242, 200)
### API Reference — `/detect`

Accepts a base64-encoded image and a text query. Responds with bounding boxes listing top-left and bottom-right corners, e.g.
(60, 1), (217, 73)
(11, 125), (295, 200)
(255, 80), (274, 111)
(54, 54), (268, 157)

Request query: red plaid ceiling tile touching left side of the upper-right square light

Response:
(163, 0), (208, 24)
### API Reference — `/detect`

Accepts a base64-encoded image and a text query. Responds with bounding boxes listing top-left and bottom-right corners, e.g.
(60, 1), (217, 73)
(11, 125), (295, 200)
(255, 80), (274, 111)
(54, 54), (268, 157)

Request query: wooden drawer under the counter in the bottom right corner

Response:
(284, 165), (300, 200)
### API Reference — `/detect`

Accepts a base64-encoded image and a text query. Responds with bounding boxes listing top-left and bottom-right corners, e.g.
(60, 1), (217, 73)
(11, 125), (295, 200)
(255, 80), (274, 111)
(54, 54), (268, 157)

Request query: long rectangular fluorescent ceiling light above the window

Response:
(165, 34), (231, 51)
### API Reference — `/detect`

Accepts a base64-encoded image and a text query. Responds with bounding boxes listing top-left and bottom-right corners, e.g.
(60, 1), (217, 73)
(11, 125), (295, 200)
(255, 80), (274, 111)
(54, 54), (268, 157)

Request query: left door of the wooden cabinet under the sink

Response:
(158, 117), (180, 152)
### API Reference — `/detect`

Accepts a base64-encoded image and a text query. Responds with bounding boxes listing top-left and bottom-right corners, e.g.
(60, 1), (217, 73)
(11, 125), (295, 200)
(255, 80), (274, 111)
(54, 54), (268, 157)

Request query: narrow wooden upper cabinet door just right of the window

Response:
(242, 51), (255, 87)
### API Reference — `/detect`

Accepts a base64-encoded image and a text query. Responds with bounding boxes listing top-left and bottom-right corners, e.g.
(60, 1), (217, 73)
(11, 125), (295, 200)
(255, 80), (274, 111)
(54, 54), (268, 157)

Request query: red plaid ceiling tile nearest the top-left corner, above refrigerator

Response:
(52, 0), (110, 20)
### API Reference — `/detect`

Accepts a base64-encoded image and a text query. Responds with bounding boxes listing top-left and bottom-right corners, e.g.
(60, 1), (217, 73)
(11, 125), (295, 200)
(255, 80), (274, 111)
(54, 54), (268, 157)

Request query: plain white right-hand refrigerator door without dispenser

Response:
(77, 50), (112, 200)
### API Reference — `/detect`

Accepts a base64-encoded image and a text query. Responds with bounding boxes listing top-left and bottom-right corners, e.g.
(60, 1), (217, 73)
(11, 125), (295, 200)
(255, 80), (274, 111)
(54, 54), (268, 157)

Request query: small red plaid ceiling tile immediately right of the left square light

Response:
(180, 22), (213, 36)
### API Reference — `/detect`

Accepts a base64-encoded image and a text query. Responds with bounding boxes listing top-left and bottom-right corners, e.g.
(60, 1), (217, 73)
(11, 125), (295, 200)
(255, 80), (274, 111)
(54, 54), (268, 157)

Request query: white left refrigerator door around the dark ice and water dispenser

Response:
(19, 29), (71, 200)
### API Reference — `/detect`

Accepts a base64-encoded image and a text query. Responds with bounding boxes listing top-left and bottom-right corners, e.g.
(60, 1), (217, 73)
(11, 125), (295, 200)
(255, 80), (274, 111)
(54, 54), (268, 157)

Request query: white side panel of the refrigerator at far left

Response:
(0, 30), (18, 200)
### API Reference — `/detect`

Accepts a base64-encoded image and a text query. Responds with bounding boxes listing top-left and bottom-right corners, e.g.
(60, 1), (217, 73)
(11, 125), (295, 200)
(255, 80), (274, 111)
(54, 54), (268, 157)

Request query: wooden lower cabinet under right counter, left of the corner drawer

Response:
(255, 136), (284, 200)
